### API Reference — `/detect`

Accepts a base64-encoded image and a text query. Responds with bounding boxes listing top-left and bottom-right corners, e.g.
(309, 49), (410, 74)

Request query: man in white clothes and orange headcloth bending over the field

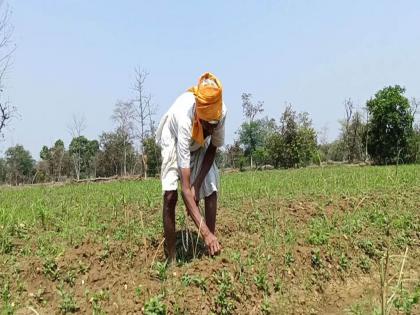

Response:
(156, 73), (226, 262)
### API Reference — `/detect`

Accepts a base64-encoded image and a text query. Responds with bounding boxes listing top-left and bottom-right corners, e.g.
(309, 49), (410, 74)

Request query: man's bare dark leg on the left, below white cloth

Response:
(163, 190), (178, 263)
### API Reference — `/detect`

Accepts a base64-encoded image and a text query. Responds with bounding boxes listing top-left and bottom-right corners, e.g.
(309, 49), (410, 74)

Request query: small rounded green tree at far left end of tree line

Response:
(5, 145), (35, 185)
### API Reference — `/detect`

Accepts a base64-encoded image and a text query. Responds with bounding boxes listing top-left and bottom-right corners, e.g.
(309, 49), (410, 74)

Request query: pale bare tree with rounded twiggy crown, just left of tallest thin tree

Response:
(112, 101), (136, 176)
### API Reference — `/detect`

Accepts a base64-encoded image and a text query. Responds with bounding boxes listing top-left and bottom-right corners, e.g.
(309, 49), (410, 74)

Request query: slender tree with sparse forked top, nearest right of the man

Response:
(239, 93), (264, 169)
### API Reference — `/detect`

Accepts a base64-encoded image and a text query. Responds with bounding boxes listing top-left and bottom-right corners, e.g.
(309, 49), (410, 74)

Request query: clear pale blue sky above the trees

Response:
(0, 0), (420, 159)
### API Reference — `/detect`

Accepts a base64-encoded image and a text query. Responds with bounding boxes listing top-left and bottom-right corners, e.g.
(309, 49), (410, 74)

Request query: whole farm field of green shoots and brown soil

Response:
(0, 165), (420, 314)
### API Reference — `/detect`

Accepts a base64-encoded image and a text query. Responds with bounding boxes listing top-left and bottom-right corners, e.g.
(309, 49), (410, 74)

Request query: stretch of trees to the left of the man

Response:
(0, 68), (160, 185)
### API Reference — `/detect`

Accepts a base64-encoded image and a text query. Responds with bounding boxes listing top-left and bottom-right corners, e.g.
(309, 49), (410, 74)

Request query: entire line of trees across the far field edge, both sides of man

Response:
(0, 84), (420, 185)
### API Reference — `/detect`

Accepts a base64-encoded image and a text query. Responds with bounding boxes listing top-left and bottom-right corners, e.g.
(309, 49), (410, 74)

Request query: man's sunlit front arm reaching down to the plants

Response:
(181, 168), (220, 255)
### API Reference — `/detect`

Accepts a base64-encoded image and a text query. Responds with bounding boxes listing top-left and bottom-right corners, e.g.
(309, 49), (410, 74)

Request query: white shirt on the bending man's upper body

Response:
(156, 92), (226, 168)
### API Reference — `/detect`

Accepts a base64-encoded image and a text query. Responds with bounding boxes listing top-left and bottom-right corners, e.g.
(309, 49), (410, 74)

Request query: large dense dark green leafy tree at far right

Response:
(366, 85), (414, 164)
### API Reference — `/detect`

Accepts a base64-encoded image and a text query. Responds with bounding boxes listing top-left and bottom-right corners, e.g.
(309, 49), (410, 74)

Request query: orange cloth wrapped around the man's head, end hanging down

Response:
(188, 72), (222, 146)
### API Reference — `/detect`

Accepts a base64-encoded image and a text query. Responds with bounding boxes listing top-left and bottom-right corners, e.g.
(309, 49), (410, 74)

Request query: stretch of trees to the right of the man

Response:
(218, 85), (420, 169)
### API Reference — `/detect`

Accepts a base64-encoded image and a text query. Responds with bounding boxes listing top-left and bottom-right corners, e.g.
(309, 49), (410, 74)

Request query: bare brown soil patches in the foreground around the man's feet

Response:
(4, 198), (419, 314)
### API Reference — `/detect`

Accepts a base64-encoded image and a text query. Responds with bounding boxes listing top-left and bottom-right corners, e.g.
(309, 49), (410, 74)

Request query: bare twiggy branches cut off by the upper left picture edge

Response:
(0, 0), (16, 134)
